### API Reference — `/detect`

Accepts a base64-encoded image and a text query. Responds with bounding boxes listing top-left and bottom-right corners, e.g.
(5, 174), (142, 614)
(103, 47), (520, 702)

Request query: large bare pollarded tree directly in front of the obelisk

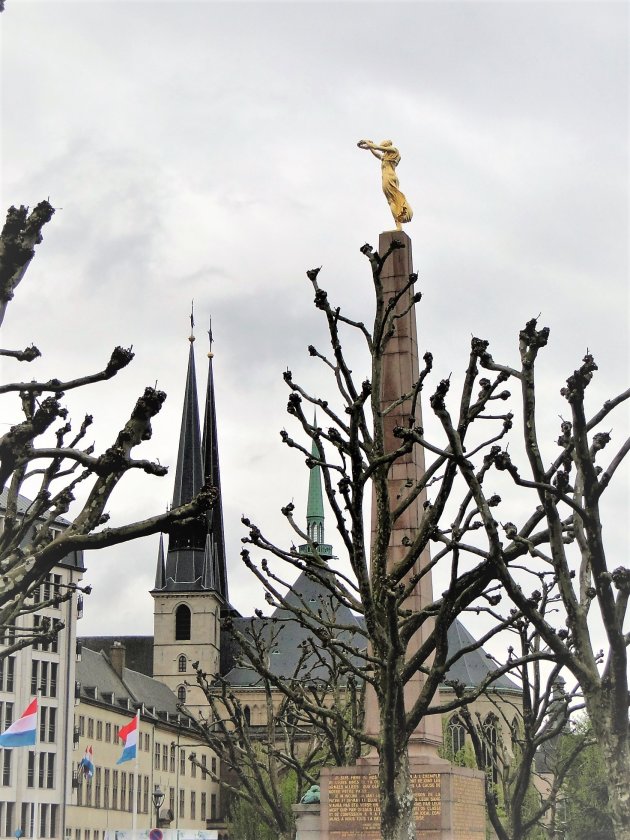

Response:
(238, 237), (592, 840)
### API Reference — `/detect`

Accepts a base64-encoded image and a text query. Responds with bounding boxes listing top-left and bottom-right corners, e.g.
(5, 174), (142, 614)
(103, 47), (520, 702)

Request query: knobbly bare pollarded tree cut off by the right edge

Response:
(456, 330), (630, 840)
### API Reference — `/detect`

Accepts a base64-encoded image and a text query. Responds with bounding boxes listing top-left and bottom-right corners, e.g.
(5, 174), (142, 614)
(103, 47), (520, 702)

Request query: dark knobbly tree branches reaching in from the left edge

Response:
(0, 201), (215, 657)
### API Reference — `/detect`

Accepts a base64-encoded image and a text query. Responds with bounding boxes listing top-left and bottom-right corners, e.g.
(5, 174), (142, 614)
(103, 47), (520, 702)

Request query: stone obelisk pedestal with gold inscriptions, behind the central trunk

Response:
(319, 759), (486, 840)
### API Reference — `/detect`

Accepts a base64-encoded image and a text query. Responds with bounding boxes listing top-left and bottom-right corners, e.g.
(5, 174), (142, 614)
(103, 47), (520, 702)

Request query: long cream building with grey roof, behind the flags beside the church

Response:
(65, 643), (220, 840)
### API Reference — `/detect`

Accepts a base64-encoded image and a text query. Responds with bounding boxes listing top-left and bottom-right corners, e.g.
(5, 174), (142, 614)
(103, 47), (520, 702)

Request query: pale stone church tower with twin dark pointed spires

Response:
(151, 318), (229, 708)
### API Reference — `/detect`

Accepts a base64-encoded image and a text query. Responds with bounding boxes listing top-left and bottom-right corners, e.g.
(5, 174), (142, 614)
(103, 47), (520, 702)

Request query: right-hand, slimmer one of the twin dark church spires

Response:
(202, 321), (228, 603)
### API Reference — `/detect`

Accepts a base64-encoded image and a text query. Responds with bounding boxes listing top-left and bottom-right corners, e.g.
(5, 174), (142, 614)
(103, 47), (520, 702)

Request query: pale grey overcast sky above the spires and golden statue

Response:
(0, 0), (629, 634)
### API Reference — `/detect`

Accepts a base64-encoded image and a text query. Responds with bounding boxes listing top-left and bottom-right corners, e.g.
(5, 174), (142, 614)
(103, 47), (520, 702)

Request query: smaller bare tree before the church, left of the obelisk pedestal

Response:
(188, 618), (364, 840)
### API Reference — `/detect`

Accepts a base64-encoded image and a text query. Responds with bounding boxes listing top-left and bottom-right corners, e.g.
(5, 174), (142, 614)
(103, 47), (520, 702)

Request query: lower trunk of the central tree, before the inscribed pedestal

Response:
(379, 746), (416, 840)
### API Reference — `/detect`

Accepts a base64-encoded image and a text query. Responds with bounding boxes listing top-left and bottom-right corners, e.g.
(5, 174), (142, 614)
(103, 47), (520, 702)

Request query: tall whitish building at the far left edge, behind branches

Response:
(0, 496), (85, 838)
